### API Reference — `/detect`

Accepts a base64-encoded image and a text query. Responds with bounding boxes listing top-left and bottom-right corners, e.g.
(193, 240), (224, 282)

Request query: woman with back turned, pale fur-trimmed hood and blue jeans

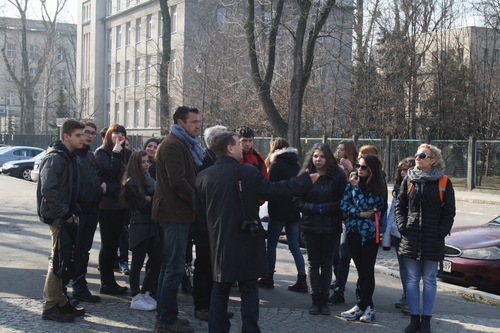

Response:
(259, 138), (307, 293)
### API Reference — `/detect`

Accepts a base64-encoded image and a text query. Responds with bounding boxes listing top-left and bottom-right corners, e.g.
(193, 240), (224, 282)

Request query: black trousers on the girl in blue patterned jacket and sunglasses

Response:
(347, 232), (379, 311)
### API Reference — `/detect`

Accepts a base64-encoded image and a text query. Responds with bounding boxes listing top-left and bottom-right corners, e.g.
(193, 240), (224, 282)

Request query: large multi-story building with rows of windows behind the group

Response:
(77, 0), (353, 136)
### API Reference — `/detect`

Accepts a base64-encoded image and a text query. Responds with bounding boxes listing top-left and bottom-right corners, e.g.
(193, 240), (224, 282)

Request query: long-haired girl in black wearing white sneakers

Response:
(121, 150), (162, 311)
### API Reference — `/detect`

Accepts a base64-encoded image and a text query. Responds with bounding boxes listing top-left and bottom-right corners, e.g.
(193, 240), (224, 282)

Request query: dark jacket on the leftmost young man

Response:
(36, 141), (80, 227)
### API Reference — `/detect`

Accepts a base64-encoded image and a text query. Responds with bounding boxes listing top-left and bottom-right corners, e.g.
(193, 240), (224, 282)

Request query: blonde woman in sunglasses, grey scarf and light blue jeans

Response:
(396, 144), (455, 333)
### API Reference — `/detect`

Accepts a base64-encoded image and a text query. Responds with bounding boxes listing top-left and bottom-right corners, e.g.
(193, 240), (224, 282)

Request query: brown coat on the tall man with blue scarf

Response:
(152, 133), (198, 223)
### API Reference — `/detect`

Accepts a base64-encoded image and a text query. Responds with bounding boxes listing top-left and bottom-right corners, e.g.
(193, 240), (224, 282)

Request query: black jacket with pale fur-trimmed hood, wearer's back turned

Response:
(267, 147), (300, 222)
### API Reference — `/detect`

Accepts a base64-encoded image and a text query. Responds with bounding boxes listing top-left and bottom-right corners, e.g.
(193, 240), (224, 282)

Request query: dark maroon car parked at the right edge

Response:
(438, 216), (500, 292)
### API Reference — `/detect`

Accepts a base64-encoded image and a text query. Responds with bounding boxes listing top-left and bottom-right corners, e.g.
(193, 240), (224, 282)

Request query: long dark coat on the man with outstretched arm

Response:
(193, 156), (311, 282)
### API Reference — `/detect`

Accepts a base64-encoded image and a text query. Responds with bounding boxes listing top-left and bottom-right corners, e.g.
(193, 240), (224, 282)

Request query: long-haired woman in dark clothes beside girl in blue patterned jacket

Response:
(293, 143), (347, 315)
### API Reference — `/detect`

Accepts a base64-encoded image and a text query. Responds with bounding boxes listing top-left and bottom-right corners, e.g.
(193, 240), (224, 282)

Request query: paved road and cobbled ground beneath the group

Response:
(0, 176), (500, 333)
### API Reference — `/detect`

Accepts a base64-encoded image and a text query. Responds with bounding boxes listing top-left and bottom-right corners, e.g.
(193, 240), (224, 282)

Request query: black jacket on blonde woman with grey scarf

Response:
(396, 177), (455, 261)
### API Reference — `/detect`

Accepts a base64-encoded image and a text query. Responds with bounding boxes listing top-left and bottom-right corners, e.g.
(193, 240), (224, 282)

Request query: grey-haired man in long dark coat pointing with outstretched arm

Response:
(193, 132), (318, 332)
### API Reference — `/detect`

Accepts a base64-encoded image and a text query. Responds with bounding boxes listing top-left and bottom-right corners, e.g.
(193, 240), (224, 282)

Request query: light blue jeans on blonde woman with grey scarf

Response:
(405, 258), (439, 316)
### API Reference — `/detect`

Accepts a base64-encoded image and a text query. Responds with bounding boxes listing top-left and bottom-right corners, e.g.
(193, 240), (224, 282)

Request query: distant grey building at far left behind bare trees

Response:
(0, 17), (78, 133)
